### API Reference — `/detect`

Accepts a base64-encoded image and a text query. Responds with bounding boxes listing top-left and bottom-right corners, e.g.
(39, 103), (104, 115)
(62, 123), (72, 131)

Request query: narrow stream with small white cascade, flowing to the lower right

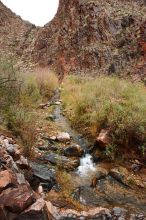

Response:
(50, 91), (146, 213)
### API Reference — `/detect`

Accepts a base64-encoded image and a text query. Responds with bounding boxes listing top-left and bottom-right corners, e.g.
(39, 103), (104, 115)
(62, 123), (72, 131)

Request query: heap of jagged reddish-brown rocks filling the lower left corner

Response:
(0, 135), (48, 220)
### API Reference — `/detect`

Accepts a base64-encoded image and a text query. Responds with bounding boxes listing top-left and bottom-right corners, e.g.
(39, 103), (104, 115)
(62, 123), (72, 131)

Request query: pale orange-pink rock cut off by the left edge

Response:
(0, 170), (17, 192)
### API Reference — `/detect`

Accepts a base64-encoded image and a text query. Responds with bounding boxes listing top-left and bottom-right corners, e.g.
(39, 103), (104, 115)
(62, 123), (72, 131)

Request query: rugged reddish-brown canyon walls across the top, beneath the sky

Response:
(0, 0), (146, 79)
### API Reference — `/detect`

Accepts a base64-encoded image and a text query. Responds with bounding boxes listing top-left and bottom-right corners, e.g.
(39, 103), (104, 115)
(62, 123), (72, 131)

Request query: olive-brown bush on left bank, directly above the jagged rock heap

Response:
(5, 106), (36, 157)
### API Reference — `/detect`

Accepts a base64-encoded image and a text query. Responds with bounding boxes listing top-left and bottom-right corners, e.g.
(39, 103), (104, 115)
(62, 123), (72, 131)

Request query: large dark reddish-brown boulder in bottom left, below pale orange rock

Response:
(0, 185), (35, 213)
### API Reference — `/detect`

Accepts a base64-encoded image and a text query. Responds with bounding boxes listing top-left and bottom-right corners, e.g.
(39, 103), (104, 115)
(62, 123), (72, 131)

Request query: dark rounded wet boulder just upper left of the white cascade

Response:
(64, 145), (84, 157)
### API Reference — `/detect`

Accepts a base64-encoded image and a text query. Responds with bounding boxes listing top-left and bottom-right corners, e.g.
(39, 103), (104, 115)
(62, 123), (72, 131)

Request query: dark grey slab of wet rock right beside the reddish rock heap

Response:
(31, 162), (56, 191)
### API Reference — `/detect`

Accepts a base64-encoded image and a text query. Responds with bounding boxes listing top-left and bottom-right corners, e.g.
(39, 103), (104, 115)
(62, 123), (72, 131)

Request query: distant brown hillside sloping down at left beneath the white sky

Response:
(0, 1), (37, 65)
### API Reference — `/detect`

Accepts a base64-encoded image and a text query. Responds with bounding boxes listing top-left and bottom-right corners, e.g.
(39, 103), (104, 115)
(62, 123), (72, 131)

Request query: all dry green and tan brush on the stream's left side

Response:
(0, 61), (58, 156)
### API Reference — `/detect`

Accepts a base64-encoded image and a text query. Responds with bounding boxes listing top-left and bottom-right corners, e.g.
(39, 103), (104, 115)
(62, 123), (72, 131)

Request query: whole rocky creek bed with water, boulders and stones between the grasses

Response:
(0, 88), (146, 220)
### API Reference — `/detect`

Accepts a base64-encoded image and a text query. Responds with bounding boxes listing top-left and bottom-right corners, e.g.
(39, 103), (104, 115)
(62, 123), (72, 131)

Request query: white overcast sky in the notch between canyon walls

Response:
(1, 0), (59, 26)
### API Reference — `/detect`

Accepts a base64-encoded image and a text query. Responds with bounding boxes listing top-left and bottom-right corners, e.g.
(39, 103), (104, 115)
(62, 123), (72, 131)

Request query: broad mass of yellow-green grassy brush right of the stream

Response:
(62, 76), (146, 152)
